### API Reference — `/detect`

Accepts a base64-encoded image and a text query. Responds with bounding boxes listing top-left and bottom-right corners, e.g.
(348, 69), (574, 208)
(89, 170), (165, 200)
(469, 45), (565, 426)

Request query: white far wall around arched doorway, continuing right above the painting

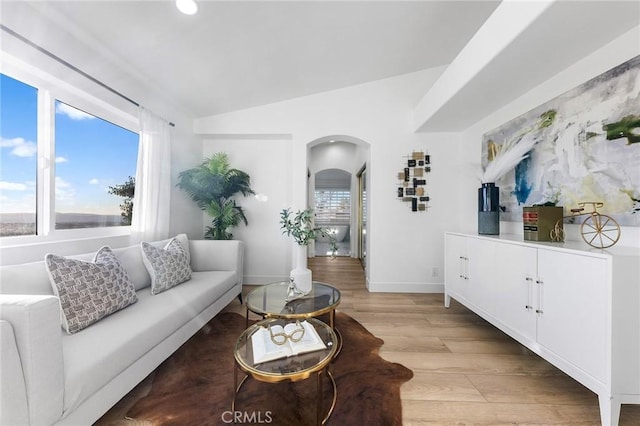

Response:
(195, 28), (640, 292)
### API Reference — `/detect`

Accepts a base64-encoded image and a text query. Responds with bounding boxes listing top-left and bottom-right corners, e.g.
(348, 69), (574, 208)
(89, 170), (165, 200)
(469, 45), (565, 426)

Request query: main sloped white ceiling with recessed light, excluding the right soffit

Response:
(0, 0), (499, 117)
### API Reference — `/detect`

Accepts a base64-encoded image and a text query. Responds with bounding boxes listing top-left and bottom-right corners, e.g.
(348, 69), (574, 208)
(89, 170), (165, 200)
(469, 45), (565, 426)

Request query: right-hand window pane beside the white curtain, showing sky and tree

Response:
(55, 101), (138, 229)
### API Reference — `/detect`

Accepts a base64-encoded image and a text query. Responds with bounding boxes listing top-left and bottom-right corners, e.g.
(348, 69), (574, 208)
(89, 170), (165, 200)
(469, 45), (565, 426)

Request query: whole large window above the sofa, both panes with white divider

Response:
(0, 74), (138, 237)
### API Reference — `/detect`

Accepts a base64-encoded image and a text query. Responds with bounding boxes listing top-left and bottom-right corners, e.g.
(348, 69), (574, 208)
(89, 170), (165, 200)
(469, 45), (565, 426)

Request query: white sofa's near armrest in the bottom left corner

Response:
(0, 294), (64, 425)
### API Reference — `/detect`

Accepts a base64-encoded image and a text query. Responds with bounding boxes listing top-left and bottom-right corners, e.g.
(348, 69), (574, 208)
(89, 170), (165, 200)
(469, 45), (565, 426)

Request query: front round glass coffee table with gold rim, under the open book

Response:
(231, 318), (338, 425)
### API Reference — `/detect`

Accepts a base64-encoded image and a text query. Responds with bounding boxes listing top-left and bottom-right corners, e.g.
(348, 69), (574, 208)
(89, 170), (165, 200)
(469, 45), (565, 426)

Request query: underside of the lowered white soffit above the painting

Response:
(420, 0), (640, 131)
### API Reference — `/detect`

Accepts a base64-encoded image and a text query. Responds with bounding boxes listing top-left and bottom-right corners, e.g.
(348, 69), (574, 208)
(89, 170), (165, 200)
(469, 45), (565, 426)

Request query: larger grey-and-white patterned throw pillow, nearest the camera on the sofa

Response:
(45, 246), (137, 333)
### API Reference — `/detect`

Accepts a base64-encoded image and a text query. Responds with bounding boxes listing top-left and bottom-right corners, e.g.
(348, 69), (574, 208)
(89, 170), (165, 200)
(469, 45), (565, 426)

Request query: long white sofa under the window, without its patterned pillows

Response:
(0, 235), (244, 426)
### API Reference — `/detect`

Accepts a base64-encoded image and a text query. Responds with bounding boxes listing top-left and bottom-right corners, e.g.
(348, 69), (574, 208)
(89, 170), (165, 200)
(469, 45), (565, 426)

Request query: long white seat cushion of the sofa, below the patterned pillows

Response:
(62, 271), (238, 412)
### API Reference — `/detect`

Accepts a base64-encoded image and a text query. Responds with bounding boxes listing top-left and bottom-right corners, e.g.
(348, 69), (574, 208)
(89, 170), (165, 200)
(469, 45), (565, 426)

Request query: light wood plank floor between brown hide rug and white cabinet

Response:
(258, 257), (640, 426)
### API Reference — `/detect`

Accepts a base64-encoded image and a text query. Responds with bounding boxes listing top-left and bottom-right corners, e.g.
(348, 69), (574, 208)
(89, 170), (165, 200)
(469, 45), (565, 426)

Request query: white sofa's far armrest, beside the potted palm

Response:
(189, 240), (244, 284)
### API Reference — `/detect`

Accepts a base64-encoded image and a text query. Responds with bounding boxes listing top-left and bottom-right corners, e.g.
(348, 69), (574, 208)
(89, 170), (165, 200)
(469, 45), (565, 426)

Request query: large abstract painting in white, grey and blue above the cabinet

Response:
(482, 56), (640, 226)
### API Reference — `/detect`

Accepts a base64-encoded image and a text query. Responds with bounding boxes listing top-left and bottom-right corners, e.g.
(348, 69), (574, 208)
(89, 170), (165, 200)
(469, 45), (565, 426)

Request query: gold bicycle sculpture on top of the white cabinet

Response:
(551, 201), (620, 248)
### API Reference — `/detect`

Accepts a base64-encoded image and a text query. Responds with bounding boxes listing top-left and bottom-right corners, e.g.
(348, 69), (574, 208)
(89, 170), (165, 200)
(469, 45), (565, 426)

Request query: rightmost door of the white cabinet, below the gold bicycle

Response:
(537, 249), (611, 382)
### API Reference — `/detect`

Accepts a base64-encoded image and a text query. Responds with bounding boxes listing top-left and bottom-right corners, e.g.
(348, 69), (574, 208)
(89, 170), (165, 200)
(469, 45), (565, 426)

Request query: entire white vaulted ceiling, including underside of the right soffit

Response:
(0, 0), (640, 130)
